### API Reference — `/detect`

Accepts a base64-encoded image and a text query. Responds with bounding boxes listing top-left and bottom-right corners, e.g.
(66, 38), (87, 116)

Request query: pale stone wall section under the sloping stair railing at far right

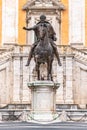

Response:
(73, 61), (87, 108)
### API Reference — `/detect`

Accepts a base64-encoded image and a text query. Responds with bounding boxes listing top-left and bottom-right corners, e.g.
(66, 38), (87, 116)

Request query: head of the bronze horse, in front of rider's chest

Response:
(38, 24), (47, 40)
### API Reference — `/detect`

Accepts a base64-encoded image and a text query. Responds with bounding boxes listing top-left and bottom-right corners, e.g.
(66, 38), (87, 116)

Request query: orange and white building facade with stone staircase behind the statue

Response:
(0, 0), (87, 108)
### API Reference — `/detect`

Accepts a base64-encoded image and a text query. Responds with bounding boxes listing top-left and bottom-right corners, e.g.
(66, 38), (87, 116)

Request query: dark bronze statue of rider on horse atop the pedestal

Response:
(23, 15), (61, 80)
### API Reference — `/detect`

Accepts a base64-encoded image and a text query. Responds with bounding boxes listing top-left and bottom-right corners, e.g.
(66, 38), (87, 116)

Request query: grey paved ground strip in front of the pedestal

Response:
(0, 122), (87, 130)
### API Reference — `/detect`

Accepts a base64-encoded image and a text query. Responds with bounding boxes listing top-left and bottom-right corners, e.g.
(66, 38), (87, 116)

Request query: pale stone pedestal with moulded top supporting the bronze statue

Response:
(28, 80), (59, 121)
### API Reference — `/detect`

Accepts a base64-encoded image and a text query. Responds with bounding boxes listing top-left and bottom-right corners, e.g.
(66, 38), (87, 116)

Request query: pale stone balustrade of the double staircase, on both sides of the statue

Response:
(0, 45), (87, 61)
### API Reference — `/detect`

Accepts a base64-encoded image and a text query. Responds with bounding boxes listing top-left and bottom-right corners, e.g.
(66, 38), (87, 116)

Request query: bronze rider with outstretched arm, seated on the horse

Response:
(23, 15), (61, 66)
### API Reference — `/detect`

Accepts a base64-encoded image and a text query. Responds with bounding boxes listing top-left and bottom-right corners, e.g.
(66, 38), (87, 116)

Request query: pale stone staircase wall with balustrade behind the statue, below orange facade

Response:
(0, 45), (87, 108)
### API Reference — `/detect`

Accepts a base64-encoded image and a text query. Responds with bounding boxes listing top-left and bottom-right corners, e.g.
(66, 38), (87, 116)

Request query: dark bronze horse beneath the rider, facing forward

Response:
(33, 24), (54, 80)
